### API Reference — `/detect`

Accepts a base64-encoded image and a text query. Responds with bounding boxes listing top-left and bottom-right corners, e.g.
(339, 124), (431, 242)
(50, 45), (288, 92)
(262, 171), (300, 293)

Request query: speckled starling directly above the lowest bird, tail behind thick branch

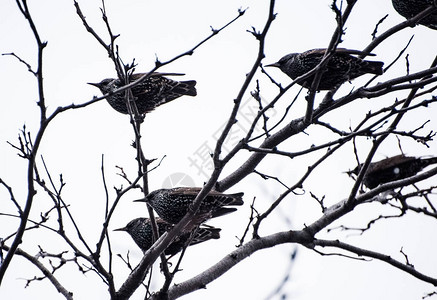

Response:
(135, 187), (244, 224)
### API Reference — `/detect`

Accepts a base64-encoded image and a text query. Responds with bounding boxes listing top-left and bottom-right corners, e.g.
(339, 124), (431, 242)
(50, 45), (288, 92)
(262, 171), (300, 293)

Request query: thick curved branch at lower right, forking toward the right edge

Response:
(168, 163), (437, 299)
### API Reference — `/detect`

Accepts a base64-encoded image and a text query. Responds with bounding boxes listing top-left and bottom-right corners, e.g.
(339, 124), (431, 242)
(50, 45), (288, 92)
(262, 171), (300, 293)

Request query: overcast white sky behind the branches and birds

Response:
(0, 0), (437, 300)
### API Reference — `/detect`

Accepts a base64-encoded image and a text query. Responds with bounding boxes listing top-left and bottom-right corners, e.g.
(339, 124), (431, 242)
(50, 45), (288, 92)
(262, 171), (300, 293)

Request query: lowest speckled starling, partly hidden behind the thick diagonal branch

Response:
(114, 218), (221, 256)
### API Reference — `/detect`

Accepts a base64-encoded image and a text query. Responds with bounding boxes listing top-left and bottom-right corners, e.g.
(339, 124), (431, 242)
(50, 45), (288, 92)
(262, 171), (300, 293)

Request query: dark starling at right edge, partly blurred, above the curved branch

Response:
(347, 154), (437, 189)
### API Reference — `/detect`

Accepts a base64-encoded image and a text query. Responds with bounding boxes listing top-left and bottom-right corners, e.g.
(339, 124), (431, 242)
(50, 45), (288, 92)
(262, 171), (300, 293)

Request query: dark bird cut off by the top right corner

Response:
(392, 0), (437, 30)
